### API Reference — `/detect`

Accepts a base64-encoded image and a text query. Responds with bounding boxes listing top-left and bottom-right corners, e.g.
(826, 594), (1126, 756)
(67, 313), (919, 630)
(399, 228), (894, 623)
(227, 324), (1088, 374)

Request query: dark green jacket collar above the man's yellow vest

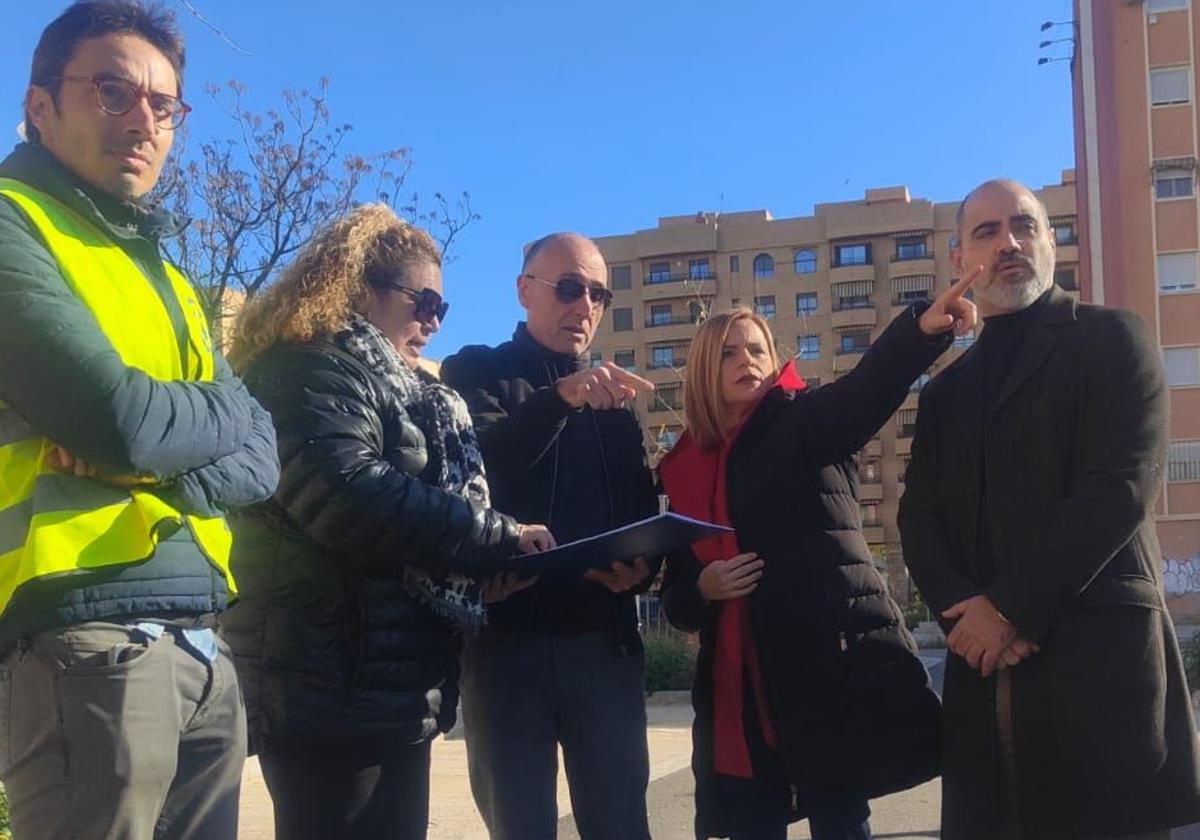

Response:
(0, 143), (187, 245)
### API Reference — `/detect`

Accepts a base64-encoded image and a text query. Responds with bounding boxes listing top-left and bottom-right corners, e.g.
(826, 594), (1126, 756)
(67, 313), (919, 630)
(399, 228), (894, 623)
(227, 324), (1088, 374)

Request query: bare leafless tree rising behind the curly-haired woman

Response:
(156, 78), (480, 336)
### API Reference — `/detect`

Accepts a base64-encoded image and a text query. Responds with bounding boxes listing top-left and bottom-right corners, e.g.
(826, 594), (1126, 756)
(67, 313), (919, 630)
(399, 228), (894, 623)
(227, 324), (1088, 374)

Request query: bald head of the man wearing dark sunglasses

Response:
(517, 233), (608, 355)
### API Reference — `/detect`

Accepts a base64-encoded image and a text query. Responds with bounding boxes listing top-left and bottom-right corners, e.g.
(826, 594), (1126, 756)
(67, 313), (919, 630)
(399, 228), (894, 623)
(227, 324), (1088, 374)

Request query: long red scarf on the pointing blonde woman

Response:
(659, 362), (805, 779)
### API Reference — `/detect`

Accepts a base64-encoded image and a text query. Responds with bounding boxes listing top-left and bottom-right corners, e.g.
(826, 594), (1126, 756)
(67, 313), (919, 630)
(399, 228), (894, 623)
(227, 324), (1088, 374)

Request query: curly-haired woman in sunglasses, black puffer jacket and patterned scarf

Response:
(221, 205), (553, 840)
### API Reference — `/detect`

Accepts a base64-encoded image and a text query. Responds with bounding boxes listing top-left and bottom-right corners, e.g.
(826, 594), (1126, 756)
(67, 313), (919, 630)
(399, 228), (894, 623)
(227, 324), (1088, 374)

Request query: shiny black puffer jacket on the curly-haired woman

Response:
(221, 340), (517, 749)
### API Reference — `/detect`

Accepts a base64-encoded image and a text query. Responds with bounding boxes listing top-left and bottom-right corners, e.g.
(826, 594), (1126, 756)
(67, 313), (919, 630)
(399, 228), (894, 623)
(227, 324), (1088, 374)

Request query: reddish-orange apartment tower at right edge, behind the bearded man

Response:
(1075, 0), (1200, 616)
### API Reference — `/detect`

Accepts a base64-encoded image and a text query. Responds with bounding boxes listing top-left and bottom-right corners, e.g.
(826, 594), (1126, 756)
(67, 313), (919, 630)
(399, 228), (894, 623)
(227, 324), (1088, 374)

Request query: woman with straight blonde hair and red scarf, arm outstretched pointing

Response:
(659, 275), (976, 840)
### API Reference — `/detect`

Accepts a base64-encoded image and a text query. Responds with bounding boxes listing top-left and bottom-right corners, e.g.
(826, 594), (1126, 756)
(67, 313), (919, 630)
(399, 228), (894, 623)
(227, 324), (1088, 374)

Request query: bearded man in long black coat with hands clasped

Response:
(900, 181), (1200, 840)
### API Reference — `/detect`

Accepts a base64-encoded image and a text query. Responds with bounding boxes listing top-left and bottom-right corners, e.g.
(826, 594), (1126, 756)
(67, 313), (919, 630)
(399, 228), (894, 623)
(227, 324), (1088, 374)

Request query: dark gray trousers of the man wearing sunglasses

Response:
(461, 632), (650, 840)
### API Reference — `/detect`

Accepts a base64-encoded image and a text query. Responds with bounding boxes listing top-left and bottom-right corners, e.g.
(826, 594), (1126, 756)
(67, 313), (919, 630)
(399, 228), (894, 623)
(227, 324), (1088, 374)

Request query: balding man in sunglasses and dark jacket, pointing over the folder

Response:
(442, 233), (658, 840)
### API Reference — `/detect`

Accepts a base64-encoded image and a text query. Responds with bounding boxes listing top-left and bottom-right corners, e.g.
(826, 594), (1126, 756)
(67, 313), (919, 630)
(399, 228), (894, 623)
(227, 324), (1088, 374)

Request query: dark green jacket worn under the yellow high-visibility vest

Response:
(0, 144), (278, 652)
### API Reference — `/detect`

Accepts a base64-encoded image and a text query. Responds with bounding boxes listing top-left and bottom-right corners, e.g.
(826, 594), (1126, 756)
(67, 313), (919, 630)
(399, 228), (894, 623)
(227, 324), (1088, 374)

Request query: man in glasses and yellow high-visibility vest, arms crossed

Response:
(0, 0), (278, 840)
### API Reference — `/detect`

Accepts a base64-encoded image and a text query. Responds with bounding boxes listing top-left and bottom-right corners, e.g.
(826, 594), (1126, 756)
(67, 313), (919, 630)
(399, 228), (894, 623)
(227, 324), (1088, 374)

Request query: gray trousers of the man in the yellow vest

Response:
(0, 622), (246, 840)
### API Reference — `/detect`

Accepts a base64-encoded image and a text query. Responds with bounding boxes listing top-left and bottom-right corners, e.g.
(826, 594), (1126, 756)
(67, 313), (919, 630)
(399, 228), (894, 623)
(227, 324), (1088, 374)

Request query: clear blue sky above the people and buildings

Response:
(0, 0), (1073, 358)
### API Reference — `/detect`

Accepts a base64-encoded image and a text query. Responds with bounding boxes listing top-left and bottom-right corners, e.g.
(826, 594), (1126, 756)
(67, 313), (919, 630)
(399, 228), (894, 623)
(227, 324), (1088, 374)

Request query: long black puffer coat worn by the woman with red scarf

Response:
(661, 308), (949, 836)
